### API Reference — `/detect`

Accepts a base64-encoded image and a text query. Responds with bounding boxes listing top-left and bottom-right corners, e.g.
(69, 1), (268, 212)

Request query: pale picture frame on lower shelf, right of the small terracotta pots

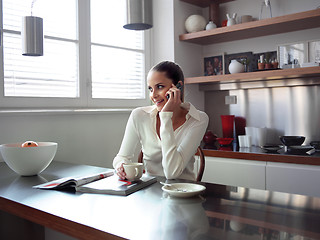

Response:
(278, 42), (308, 68)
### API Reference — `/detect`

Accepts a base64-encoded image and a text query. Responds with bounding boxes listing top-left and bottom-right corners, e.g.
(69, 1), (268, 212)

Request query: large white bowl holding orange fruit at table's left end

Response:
(0, 142), (58, 176)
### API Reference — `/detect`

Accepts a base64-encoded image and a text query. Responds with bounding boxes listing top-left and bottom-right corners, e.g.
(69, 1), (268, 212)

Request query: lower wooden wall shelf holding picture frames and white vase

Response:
(185, 67), (320, 84)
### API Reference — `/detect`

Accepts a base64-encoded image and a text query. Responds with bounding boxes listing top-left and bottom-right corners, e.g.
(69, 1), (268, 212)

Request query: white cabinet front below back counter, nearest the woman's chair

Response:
(202, 157), (266, 189)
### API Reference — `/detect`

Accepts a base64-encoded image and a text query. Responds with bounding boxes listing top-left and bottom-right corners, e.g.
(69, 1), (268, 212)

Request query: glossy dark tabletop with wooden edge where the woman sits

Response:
(0, 161), (320, 240)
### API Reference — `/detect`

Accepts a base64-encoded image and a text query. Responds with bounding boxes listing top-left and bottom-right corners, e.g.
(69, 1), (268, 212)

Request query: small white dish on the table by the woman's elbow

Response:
(162, 183), (206, 198)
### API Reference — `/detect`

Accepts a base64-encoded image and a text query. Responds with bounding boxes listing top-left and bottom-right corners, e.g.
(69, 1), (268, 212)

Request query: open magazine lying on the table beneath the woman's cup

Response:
(33, 170), (157, 196)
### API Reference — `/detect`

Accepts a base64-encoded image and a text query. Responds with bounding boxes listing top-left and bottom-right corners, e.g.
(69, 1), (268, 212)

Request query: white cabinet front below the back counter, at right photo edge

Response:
(266, 162), (320, 197)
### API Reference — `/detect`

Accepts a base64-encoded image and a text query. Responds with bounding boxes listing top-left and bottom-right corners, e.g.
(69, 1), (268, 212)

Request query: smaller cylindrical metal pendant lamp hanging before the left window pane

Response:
(21, 16), (43, 56)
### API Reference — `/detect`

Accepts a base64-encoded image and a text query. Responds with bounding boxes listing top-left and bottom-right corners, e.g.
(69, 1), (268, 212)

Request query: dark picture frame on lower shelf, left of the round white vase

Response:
(203, 53), (225, 76)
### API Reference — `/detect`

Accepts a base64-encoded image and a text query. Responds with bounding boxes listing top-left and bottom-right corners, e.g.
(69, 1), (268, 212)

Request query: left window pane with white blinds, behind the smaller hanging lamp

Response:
(2, 0), (79, 98)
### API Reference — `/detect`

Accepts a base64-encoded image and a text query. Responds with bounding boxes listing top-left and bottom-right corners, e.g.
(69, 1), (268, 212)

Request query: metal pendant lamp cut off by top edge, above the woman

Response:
(123, 0), (153, 30)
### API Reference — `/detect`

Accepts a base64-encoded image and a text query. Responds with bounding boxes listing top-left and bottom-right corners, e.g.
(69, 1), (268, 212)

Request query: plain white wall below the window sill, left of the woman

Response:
(0, 112), (130, 167)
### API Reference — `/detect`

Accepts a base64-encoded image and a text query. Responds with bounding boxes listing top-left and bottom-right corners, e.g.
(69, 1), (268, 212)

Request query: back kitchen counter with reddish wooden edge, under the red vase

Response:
(203, 145), (320, 166)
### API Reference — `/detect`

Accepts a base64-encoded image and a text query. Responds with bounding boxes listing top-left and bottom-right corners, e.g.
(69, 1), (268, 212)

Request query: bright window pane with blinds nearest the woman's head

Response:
(91, 0), (145, 99)
